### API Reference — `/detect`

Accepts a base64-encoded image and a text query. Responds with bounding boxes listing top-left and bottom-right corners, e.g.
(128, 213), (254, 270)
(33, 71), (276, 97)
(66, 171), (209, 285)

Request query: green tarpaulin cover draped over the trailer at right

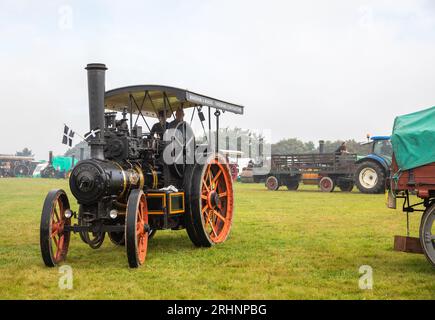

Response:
(391, 107), (435, 170)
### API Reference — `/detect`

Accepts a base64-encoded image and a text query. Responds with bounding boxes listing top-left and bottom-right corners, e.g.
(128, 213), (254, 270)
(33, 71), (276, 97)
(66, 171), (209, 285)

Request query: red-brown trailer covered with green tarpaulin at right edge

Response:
(387, 107), (435, 267)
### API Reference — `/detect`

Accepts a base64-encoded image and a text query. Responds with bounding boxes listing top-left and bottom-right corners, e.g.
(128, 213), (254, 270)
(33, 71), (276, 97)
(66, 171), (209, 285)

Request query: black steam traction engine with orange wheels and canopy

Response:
(40, 64), (243, 268)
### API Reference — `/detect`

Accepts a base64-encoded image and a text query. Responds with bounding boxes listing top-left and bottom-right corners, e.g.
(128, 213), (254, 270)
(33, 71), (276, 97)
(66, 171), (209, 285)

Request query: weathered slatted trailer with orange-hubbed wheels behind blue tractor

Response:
(263, 153), (357, 192)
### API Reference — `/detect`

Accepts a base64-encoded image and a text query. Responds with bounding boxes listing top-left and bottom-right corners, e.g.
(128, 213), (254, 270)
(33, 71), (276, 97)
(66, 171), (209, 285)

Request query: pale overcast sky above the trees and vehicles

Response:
(0, 0), (435, 159)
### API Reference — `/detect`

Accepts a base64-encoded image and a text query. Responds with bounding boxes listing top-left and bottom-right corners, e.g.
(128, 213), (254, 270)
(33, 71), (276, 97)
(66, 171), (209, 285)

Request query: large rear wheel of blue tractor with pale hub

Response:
(355, 161), (385, 193)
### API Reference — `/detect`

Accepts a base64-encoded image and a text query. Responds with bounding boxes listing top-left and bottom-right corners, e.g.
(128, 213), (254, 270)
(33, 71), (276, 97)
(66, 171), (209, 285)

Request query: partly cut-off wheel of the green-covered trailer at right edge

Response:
(420, 203), (435, 267)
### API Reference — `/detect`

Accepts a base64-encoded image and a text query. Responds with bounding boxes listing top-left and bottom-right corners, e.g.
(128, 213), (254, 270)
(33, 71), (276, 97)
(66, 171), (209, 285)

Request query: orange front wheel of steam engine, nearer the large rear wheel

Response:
(125, 189), (149, 268)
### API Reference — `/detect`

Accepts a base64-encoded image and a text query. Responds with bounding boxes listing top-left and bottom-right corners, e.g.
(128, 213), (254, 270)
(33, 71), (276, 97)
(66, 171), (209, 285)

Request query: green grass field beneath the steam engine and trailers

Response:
(0, 179), (435, 299)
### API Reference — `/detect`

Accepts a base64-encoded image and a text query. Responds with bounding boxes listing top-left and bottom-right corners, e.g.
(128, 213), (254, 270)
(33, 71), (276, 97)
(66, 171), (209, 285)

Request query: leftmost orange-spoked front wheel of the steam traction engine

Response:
(39, 189), (71, 267)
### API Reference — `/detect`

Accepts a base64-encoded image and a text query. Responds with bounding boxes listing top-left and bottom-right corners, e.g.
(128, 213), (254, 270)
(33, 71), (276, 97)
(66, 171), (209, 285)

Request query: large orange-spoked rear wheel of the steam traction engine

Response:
(186, 154), (234, 247)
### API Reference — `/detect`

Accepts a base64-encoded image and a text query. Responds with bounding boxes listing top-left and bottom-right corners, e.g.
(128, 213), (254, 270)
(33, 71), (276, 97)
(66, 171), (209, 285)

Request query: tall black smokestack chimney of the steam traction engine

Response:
(86, 63), (107, 160)
